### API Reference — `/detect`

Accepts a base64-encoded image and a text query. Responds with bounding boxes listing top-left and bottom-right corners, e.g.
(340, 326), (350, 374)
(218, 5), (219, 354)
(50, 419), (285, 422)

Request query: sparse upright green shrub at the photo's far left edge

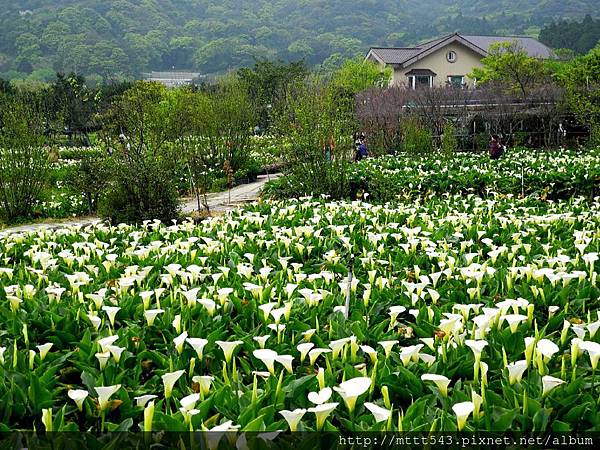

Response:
(0, 96), (49, 221)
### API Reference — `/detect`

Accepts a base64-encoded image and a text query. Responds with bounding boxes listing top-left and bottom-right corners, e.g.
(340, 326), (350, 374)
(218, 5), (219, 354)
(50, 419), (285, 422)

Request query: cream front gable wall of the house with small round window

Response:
(391, 42), (482, 87)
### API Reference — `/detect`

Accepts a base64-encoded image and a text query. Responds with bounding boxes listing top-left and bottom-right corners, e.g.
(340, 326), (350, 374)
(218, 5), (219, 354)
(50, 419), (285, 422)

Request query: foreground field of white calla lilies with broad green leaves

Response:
(0, 195), (600, 432)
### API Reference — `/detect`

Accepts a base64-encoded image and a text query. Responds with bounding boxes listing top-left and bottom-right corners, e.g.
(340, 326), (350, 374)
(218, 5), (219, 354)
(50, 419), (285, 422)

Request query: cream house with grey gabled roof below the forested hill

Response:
(365, 33), (552, 89)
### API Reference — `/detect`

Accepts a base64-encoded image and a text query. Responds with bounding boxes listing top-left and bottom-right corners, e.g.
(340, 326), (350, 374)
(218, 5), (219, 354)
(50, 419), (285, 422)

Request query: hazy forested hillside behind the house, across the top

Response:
(0, 0), (597, 79)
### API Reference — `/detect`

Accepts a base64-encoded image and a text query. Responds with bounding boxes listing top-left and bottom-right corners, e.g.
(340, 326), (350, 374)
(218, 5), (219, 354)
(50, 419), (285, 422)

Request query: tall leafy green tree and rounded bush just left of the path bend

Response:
(98, 82), (179, 223)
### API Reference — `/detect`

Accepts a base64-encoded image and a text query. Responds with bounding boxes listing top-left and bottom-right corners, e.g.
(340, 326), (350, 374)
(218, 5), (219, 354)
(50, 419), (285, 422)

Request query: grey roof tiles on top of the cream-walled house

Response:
(371, 34), (552, 64)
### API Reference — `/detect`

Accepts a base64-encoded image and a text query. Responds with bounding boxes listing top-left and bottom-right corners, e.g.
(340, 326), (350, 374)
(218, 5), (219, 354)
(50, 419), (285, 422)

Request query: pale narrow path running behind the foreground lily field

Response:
(0, 173), (281, 238)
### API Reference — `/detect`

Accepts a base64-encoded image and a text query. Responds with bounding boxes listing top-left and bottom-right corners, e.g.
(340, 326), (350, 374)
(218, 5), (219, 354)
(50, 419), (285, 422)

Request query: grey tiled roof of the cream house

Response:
(367, 33), (552, 65)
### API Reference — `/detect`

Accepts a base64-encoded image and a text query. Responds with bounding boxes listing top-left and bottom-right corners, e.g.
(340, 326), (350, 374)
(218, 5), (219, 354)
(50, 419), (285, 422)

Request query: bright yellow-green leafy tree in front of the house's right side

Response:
(469, 41), (549, 100)
